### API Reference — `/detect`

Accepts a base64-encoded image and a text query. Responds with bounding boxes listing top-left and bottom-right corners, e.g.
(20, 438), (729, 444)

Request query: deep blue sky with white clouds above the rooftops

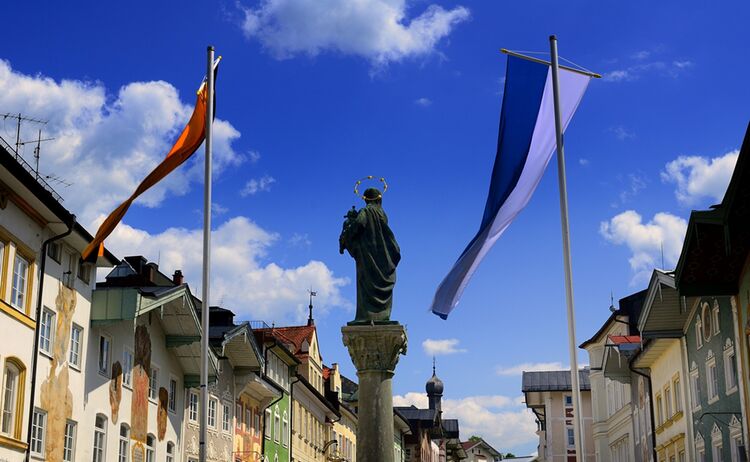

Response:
(0, 0), (750, 453)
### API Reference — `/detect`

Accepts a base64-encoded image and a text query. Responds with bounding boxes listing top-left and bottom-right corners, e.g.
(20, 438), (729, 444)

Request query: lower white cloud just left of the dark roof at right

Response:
(599, 210), (687, 284)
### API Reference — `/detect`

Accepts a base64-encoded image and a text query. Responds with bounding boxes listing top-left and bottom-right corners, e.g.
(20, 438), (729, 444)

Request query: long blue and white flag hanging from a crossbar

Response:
(432, 56), (591, 319)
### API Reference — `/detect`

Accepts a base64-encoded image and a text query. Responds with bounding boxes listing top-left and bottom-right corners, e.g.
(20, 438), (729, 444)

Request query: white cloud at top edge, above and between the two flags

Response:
(240, 0), (469, 67)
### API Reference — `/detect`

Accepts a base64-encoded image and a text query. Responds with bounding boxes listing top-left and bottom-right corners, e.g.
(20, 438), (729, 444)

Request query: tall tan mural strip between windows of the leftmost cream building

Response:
(39, 282), (76, 462)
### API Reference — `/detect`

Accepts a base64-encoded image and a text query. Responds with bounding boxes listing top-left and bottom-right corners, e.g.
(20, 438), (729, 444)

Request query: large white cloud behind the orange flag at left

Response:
(0, 60), (244, 225)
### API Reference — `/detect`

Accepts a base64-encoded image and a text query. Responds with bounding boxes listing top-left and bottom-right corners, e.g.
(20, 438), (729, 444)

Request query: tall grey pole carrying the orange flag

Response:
(199, 45), (214, 462)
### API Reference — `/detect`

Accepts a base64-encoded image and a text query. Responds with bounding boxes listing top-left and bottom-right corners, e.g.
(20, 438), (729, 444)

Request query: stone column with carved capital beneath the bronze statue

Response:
(341, 323), (406, 462)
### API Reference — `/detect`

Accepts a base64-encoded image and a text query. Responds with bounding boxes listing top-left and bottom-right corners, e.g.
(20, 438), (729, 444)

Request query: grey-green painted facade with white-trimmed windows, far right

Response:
(685, 297), (744, 462)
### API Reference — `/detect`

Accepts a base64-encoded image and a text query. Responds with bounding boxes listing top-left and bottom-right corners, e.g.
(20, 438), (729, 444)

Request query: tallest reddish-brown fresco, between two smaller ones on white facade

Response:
(130, 324), (151, 442)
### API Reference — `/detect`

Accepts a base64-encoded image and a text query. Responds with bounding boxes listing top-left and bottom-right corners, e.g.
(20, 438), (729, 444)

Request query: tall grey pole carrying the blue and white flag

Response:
(549, 35), (585, 461)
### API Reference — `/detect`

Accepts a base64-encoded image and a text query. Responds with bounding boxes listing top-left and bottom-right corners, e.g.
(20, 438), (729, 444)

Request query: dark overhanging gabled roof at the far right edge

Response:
(675, 124), (750, 295)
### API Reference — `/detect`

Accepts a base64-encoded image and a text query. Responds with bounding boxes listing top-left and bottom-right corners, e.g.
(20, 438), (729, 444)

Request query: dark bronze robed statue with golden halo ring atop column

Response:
(339, 185), (401, 325)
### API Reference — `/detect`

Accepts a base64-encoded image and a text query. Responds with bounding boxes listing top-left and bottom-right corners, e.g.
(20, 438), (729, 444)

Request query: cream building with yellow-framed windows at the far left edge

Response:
(0, 139), (116, 461)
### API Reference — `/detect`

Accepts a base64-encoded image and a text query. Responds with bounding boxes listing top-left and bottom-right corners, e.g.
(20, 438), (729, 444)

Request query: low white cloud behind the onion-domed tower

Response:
(393, 392), (538, 452)
